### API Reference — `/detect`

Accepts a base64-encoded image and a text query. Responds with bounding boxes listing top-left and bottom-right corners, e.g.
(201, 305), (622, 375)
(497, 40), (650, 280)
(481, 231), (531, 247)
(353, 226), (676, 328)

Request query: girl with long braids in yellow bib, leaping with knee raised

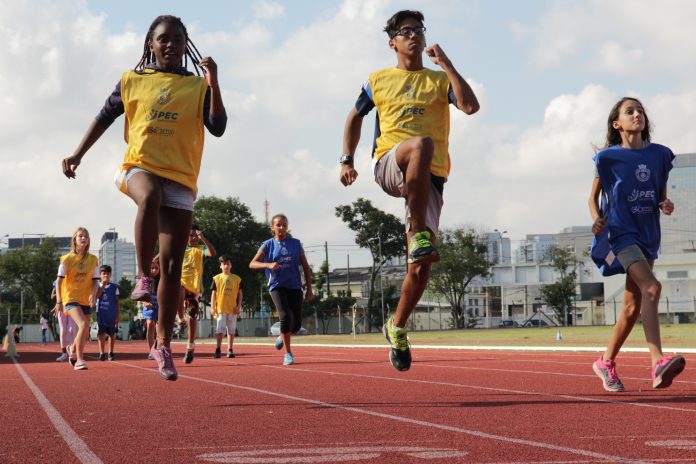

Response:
(62, 16), (227, 380)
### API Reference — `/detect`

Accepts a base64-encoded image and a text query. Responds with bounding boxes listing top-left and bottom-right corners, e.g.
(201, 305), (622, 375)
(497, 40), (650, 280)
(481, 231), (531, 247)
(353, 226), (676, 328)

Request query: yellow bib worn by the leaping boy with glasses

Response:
(368, 68), (450, 178)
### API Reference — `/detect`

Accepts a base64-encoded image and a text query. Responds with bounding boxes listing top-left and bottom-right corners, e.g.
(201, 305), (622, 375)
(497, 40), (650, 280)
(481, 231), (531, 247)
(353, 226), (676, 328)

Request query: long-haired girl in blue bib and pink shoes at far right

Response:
(588, 98), (686, 392)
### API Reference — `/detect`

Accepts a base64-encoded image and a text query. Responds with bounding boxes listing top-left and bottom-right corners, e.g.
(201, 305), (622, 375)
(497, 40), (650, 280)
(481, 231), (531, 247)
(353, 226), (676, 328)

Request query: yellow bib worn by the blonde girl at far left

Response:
(58, 252), (99, 306)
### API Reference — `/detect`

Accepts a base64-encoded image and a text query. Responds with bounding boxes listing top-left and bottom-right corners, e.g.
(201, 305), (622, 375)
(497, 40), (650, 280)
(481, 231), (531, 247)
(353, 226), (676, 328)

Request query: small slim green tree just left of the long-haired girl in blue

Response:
(541, 245), (578, 325)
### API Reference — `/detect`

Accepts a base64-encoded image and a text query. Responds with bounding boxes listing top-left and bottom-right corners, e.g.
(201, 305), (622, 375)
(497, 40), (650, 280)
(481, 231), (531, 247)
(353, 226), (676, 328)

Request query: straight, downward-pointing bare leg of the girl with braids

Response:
(157, 207), (193, 348)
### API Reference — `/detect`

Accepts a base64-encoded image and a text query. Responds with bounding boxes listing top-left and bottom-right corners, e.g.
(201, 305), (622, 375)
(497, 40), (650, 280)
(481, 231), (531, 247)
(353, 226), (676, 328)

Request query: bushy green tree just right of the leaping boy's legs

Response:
(428, 228), (491, 329)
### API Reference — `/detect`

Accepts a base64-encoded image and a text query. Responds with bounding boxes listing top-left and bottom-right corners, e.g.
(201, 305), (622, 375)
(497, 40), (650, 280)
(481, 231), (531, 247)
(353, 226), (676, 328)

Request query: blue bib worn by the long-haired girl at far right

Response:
(594, 143), (674, 259)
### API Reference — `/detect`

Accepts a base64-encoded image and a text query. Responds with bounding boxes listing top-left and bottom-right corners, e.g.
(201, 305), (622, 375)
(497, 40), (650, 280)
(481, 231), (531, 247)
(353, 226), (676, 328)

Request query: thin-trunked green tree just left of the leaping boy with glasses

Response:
(336, 198), (406, 331)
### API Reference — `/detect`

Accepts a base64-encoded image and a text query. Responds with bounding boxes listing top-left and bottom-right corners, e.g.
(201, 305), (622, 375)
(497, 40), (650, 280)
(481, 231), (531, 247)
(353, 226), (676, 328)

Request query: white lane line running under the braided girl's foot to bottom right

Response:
(120, 363), (652, 464)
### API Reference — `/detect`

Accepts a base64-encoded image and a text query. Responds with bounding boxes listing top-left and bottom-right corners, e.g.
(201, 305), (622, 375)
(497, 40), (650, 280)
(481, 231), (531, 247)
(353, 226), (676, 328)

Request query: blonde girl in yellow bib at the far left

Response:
(53, 227), (99, 371)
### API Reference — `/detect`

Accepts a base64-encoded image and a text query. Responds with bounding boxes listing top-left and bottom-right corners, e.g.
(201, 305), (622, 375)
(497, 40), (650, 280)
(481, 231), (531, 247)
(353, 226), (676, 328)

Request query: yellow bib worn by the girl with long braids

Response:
(121, 71), (208, 193)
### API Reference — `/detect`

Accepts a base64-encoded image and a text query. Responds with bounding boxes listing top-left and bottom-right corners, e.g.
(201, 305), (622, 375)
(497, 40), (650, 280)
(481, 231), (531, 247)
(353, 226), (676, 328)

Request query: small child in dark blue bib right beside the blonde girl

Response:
(97, 264), (121, 361)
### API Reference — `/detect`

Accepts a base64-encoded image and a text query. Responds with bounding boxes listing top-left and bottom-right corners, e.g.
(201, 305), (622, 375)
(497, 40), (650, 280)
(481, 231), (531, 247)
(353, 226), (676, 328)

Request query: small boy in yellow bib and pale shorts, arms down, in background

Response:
(210, 255), (242, 358)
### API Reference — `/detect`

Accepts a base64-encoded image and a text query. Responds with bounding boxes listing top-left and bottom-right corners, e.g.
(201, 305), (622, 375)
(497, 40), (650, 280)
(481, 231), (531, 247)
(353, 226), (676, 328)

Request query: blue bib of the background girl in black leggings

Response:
(259, 237), (304, 290)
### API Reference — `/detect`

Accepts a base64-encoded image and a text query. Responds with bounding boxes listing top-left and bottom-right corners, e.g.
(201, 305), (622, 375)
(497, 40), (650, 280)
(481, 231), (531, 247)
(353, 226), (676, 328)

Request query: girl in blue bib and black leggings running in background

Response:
(249, 214), (314, 366)
